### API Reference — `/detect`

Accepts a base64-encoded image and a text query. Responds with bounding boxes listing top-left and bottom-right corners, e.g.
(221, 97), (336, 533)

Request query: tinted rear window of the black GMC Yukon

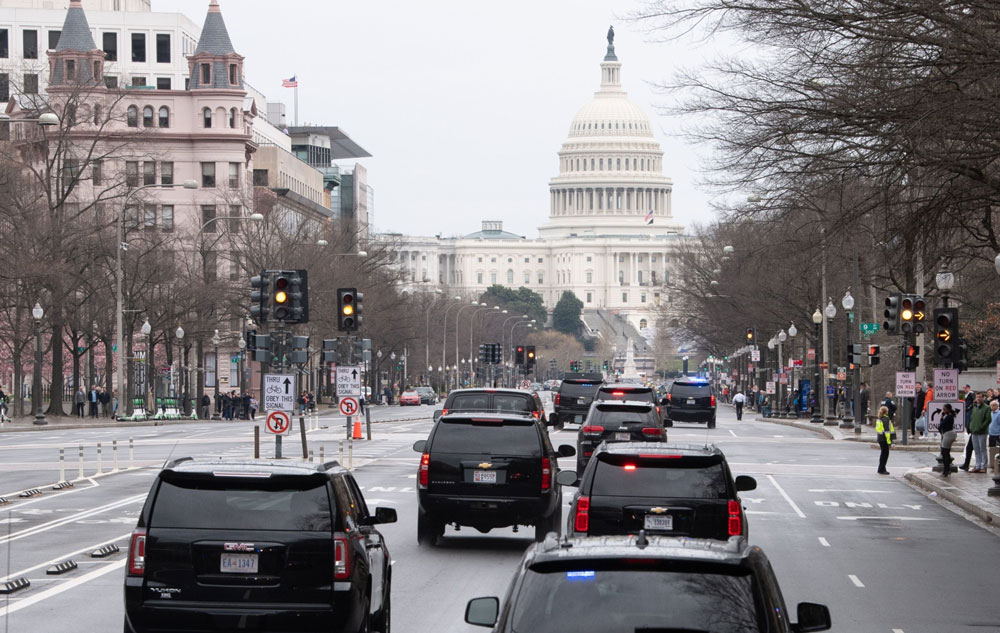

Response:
(149, 475), (332, 531)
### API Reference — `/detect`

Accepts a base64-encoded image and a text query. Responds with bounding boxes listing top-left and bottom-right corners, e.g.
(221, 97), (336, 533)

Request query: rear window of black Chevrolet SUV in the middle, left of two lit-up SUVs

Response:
(431, 418), (541, 455)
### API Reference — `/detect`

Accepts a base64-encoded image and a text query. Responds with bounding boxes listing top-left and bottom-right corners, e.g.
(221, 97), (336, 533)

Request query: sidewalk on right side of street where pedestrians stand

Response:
(754, 408), (1000, 527)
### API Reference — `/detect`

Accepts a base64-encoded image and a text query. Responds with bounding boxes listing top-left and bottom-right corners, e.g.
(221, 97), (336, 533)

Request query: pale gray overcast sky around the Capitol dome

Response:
(153, 0), (710, 237)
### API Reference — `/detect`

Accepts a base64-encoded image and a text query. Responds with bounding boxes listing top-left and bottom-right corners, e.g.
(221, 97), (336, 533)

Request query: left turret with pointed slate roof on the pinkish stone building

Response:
(49, 0), (105, 90)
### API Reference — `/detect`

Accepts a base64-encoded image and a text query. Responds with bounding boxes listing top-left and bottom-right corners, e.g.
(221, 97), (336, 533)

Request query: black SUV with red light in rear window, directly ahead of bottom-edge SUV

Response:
(559, 442), (757, 540)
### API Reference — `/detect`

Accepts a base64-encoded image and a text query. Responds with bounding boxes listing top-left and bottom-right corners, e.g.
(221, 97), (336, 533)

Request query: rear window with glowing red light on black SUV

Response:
(590, 454), (729, 499)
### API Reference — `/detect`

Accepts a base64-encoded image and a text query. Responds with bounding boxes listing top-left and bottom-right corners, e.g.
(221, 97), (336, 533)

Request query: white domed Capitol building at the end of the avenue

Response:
(382, 34), (684, 349)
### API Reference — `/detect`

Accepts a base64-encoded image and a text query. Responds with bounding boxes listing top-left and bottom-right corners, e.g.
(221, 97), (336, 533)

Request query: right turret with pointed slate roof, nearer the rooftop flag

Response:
(188, 0), (243, 90)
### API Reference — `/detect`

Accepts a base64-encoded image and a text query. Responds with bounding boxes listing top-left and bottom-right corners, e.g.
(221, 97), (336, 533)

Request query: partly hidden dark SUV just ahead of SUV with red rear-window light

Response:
(576, 400), (667, 473)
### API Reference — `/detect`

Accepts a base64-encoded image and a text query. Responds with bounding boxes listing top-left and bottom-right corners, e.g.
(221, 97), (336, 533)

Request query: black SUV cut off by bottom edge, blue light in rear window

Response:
(465, 534), (830, 633)
